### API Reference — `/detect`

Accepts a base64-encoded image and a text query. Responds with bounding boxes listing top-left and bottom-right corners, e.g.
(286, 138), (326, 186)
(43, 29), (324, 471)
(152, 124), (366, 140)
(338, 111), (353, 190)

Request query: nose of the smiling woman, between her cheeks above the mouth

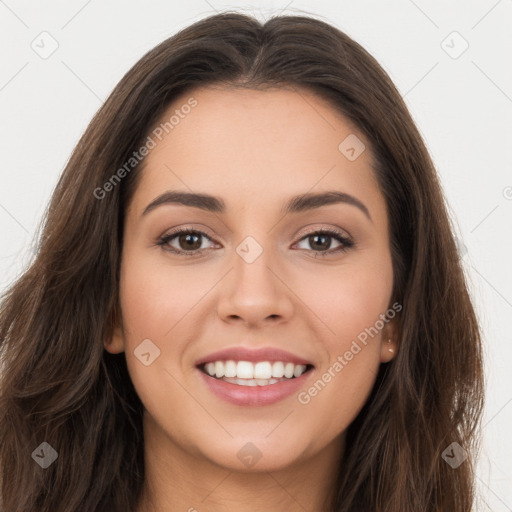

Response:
(217, 247), (294, 327)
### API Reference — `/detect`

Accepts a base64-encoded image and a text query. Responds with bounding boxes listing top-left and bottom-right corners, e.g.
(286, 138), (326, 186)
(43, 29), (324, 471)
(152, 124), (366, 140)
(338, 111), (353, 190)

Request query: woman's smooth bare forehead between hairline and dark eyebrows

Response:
(128, 83), (383, 218)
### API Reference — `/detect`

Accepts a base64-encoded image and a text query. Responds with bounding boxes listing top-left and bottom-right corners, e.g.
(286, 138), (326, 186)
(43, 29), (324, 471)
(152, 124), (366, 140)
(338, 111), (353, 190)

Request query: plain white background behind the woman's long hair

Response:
(0, 0), (512, 512)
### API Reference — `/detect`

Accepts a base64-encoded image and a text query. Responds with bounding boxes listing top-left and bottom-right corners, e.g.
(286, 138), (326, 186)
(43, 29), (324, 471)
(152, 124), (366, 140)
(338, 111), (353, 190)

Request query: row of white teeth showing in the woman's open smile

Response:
(204, 360), (306, 380)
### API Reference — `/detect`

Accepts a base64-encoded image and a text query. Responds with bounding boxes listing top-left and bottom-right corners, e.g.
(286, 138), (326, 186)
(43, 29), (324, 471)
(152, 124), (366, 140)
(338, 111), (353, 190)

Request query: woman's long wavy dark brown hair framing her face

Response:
(0, 12), (483, 512)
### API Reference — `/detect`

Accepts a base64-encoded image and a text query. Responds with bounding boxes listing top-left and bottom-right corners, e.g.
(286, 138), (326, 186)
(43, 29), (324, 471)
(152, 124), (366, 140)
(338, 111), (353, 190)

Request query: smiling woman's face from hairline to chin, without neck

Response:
(106, 87), (396, 471)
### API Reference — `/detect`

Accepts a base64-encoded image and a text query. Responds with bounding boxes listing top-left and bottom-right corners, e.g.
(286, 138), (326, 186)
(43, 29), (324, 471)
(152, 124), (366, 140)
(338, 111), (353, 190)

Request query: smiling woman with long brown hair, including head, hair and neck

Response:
(0, 13), (483, 512)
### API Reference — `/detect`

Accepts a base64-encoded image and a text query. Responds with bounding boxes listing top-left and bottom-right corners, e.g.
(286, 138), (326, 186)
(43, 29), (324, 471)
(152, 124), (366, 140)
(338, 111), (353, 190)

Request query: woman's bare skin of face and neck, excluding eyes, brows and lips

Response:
(105, 87), (396, 512)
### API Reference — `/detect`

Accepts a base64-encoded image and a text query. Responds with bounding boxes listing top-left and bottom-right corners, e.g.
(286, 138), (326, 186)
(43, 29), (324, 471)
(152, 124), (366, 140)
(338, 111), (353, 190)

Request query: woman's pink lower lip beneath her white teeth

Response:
(197, 369), (313, 406)
